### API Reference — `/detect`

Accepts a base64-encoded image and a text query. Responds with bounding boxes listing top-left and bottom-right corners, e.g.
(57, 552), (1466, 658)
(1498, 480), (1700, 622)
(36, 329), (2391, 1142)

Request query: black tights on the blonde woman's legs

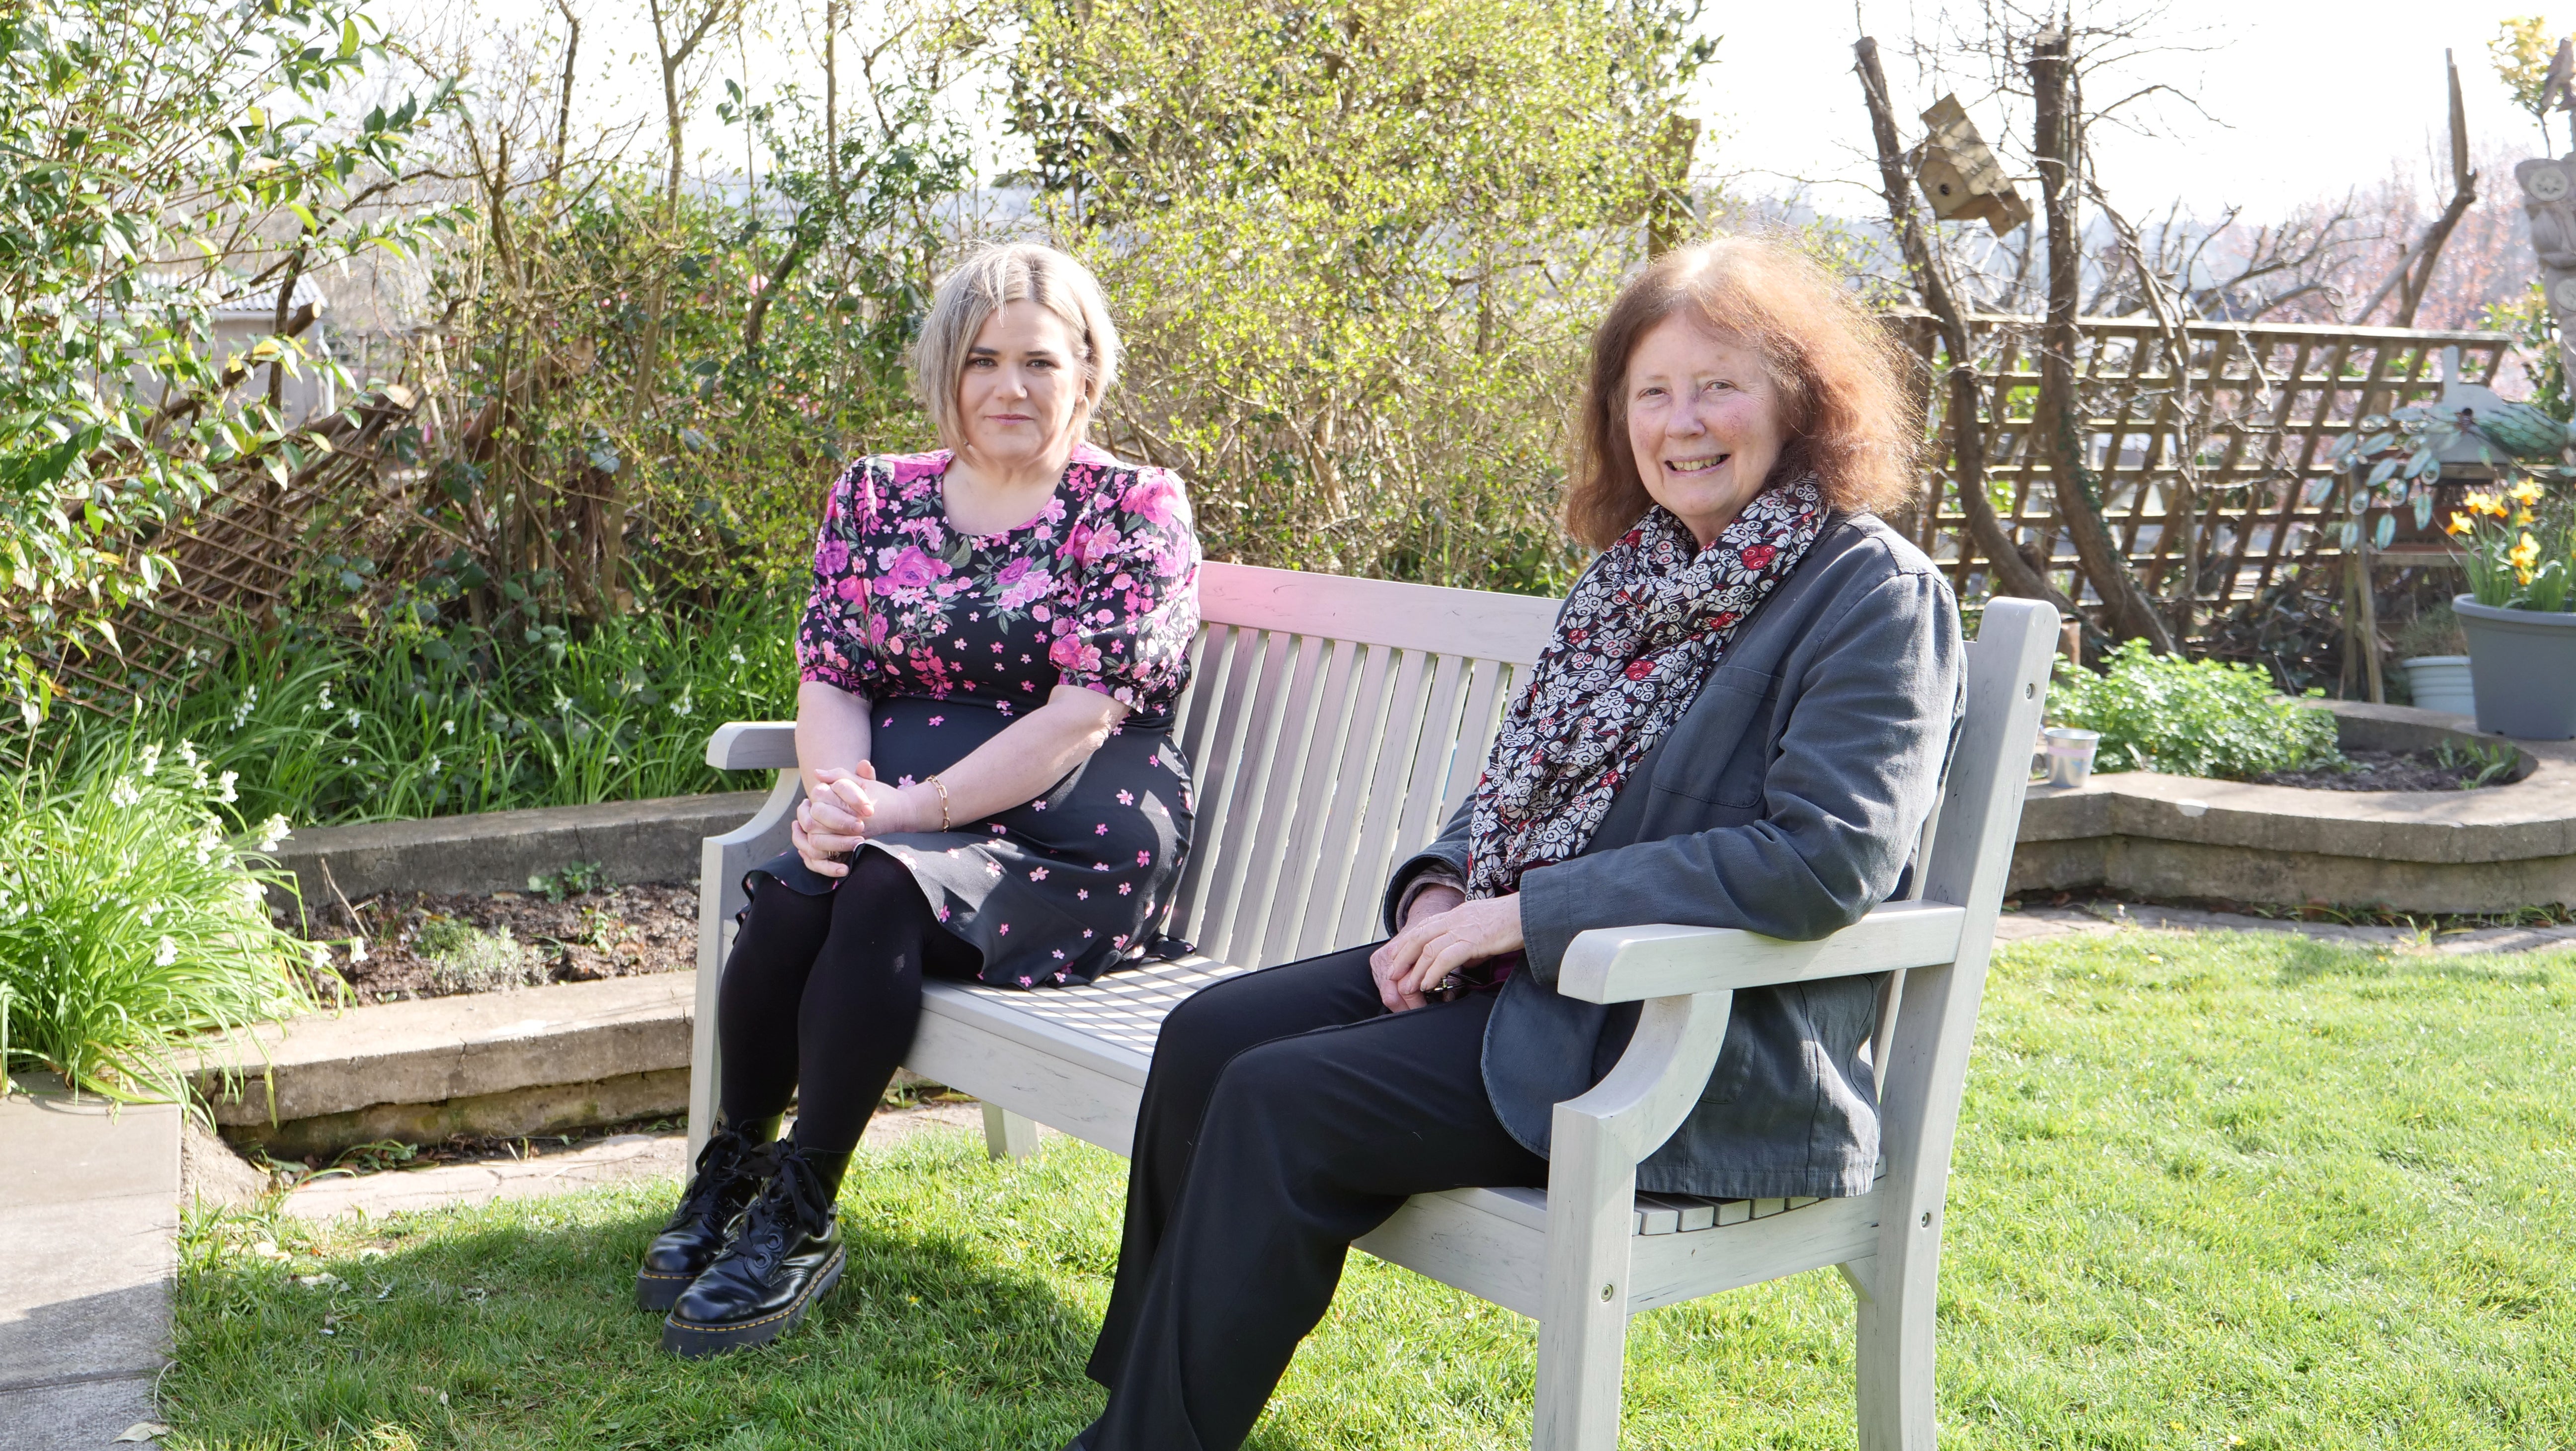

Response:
(716, 851), (981, 1155)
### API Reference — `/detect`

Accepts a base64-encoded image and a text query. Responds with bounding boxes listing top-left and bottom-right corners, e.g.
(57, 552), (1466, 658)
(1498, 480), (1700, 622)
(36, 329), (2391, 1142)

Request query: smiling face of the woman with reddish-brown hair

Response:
(1623, 312), (1788, 549)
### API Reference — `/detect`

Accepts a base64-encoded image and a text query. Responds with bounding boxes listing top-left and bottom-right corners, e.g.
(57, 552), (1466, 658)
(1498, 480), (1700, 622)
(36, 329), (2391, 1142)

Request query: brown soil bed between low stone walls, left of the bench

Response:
(304, 882), (698, 1003)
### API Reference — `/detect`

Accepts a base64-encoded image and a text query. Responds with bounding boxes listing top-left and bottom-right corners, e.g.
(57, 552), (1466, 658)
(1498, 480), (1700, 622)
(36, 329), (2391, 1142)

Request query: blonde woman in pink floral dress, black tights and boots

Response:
(636, 245), (1198, 1356)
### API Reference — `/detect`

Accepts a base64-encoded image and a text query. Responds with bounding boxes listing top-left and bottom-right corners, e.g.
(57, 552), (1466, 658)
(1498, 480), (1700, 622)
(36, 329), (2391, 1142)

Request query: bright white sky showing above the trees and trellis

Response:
(469, 0), (2576, 219)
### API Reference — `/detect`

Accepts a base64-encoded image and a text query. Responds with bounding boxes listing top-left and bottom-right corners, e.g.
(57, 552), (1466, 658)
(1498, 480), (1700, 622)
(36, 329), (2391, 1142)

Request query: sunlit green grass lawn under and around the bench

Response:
(165, 930), (2576, 1451)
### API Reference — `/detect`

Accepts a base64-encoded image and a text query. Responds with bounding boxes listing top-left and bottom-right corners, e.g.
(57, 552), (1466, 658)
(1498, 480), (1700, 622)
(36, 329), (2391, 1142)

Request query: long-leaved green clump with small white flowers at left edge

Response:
(0, 737), (312, 1101)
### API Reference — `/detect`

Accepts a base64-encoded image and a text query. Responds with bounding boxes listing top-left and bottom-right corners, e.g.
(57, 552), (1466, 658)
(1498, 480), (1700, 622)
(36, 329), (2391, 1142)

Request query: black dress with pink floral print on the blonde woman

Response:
(757, 446), (1198, 987)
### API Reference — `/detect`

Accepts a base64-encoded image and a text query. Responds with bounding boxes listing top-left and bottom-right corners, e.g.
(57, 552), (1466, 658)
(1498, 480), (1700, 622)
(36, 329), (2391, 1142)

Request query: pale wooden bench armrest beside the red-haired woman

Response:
(1556, 902), (1968, 1003)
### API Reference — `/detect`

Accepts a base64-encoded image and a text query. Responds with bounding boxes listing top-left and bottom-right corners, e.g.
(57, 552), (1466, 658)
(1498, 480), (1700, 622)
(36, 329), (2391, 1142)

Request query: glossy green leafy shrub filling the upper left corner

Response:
(0, 0), (451, 722)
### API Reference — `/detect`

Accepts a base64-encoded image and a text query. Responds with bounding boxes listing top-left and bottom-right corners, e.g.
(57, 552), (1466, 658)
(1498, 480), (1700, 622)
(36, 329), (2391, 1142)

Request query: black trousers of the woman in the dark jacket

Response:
(1082, 949), (1548, 1451)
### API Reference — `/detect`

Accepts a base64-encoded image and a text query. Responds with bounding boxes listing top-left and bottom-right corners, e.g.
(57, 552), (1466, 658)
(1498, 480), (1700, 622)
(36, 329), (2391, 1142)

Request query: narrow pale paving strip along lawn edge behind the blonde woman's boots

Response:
(283, 1103), (984, 1219)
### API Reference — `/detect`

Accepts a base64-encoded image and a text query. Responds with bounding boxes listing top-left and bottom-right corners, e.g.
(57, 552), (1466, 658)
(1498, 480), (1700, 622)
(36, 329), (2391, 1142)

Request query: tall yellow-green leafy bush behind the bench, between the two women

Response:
(1010, 0), (1710, 593)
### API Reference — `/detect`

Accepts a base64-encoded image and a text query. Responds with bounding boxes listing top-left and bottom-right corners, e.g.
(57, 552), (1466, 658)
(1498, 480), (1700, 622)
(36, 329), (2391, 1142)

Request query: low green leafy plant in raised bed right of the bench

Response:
(2048, 639), (2344, 781)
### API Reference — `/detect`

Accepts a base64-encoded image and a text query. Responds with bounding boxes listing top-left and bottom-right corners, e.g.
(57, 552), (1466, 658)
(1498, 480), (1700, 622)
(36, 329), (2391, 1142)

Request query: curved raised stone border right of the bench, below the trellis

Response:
(2010, 701), (2576, 912)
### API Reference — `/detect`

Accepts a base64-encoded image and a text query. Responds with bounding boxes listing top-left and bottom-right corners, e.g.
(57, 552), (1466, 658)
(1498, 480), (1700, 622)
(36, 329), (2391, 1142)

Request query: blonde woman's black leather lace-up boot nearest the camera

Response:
(662, 1147), (850, 1358)
